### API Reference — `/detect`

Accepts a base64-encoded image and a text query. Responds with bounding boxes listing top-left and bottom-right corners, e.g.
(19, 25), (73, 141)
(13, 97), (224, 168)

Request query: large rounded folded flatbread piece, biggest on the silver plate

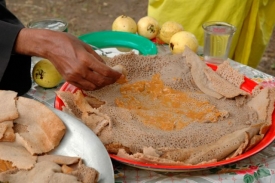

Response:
(14, 97), (65, 154)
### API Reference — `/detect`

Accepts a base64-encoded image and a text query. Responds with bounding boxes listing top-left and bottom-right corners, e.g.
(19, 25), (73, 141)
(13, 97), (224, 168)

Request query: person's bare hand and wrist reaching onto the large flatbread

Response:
(15, 28), (121, 90)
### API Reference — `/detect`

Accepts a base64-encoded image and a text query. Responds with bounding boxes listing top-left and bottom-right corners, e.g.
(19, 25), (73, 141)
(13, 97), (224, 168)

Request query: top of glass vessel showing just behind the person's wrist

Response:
(27, 18), (68, 32)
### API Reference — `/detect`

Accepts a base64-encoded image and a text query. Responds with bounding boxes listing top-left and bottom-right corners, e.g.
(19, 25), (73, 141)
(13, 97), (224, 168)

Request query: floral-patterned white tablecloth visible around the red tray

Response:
(25, 46), (275, 183)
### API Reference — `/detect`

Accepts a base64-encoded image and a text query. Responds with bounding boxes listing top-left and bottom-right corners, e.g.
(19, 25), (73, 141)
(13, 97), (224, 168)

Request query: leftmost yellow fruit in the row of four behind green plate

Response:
(112, 15), (137, 33)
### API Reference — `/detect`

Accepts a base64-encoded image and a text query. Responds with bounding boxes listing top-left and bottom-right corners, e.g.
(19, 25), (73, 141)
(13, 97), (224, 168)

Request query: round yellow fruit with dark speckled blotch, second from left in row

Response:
(137, 16), (159, 39)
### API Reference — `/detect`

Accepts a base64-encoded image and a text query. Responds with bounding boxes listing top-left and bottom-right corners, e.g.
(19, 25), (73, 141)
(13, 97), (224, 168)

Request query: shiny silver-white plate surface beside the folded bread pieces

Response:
(49, 107), (114, 183)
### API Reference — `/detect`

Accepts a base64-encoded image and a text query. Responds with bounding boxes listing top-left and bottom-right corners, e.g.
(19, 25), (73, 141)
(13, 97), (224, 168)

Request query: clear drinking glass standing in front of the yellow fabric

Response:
(202, 22), (236, 65)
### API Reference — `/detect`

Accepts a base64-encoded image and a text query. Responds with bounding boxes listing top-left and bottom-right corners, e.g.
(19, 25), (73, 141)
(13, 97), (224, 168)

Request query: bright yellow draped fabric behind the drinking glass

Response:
(148, 0), (275, 67)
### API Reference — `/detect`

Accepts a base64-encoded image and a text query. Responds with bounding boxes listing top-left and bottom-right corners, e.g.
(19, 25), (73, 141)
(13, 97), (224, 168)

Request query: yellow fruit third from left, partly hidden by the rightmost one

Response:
(159, 21), (184, 44)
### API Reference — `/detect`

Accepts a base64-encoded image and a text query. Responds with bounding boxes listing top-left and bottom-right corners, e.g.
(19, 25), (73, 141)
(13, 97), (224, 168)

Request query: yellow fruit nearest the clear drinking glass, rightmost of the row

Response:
(169, 31), (199, 54)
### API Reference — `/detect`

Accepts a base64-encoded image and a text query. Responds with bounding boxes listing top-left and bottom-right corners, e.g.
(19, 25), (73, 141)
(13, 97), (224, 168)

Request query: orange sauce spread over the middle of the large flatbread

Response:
(115, 74), (226, 131)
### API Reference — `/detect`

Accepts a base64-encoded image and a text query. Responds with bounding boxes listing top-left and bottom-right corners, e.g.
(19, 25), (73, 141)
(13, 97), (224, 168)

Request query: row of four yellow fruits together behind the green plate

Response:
(112, 15), (199, 54)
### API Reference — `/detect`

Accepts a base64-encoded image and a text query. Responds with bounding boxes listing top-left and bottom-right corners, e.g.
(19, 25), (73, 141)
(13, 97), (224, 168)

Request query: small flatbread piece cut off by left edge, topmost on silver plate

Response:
(0, 90), (19, 123)
